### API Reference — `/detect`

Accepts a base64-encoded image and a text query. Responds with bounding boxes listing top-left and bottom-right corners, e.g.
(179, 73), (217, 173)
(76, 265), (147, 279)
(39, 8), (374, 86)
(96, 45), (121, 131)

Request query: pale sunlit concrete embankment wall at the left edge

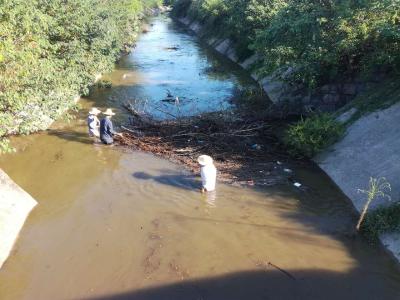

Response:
(0, 169), (37, 268)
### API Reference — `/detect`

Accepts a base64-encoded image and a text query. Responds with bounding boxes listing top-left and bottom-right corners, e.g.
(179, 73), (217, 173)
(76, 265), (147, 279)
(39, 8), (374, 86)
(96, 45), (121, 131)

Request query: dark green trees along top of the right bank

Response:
(172, 0), (400, 88)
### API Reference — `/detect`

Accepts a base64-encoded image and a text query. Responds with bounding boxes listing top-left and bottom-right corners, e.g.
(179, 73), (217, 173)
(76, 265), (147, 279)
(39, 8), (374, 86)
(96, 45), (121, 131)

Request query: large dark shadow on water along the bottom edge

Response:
(90, 268), (400, 300)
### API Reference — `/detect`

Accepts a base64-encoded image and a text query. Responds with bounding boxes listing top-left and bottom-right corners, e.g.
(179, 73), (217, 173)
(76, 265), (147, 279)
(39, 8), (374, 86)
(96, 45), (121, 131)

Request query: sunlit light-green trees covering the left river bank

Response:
(0, 0), (158, 152)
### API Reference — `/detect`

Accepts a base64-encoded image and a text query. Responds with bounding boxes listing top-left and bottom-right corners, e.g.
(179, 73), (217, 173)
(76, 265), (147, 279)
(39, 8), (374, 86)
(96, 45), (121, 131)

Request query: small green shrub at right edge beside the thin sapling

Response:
(360, 203), (400, 242)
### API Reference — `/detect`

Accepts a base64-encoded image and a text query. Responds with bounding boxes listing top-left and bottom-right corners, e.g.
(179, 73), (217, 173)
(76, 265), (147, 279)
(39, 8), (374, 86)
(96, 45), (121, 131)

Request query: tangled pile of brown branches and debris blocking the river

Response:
(119, 105), (287, 185)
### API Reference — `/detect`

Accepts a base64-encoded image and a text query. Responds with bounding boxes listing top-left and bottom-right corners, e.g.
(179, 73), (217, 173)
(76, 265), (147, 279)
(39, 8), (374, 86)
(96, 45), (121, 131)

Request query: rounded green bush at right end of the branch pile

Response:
(284, 114), (344, 158)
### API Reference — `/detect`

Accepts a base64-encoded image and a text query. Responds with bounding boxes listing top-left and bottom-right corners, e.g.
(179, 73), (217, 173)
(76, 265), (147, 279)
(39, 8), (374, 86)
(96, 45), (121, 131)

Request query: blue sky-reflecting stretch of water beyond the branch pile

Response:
(101, 17), (251, 118)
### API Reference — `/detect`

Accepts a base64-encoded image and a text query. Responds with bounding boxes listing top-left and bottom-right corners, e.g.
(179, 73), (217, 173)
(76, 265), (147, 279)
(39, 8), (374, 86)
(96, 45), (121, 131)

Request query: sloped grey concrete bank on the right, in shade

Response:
(315, 103), (400, 261)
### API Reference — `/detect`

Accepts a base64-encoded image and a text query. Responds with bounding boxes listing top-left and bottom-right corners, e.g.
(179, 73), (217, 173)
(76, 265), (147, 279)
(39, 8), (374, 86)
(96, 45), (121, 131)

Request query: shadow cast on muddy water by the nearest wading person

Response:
(132, 172), (201, 191)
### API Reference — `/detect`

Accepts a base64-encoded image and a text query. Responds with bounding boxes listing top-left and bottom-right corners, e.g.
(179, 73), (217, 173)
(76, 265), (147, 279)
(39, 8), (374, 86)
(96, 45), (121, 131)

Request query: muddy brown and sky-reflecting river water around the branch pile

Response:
(0, 17), (400, 300)
